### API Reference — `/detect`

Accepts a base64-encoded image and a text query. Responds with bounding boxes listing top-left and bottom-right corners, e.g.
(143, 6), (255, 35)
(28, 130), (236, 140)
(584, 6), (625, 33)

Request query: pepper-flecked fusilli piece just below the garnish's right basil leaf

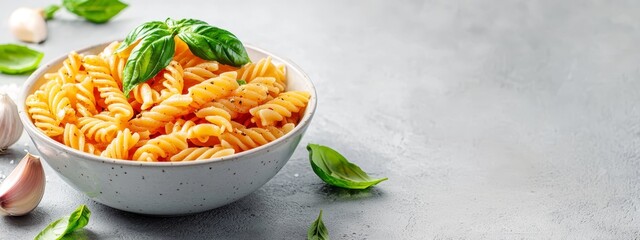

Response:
(188, 72), (239, 109)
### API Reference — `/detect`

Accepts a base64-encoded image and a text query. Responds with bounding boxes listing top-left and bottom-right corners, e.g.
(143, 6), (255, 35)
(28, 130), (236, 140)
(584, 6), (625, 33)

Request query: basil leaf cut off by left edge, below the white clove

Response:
(0, 44), (44, 74)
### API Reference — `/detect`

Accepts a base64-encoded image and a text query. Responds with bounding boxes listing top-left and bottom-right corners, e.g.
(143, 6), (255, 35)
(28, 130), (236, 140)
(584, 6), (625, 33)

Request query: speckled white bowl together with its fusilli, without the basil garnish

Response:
(18, 38), (316, 215)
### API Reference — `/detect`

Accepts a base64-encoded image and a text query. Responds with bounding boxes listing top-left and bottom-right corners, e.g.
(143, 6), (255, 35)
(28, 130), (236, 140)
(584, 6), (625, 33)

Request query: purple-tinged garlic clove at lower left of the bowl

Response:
(0, 153), (46, 216)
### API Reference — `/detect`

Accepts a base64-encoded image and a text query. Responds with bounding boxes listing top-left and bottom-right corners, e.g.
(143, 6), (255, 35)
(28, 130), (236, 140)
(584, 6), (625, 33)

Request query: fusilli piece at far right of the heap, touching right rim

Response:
(249, 91), (311, 126)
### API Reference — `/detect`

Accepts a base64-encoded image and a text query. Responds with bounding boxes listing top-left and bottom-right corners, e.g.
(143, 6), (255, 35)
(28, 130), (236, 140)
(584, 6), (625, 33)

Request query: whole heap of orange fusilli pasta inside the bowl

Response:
(25, 38), (310, 161)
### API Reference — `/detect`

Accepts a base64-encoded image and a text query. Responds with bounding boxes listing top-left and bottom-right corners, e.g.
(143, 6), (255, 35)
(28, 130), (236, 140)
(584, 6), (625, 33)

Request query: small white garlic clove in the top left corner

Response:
(9, 8), (47, 43)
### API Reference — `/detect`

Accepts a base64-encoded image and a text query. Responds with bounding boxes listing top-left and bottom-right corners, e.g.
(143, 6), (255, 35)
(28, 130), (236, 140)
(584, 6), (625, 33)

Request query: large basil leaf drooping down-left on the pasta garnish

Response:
(122, 29), (176, 97)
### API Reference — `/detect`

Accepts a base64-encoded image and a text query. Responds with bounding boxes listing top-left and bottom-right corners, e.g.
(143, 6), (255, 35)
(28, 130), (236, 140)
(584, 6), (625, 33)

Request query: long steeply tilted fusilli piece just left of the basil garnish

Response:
(83, 55), (133, 121)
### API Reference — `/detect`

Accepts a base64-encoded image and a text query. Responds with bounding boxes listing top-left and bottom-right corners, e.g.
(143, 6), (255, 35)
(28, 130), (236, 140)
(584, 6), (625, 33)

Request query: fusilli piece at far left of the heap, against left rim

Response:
(25, 90), (64, 137)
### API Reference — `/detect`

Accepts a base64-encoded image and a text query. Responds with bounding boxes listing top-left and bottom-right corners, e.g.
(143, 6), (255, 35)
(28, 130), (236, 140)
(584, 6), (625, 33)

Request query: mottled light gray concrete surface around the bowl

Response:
(0, 0), (640, 239)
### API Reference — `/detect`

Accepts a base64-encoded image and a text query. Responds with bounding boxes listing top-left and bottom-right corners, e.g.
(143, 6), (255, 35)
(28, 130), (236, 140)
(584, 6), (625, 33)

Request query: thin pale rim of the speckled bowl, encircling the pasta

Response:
(17, 40), (317, 167)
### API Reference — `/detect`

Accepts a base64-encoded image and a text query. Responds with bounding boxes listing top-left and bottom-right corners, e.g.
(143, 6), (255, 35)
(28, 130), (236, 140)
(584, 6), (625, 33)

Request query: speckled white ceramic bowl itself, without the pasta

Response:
(17, 43), (316, 215)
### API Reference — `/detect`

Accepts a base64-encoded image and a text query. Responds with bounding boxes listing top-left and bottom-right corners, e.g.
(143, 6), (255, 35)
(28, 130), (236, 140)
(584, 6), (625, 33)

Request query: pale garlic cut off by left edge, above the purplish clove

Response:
(0, 93), (22, 152)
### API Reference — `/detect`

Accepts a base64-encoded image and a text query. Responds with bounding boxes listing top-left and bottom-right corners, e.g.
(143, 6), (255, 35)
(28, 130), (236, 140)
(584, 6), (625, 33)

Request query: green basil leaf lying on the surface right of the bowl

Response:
(307, 143), (387, 189)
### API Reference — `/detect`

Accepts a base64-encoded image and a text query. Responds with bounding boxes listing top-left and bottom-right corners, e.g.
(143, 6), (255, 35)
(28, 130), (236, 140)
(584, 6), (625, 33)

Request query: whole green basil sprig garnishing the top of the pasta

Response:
(116, 18), (250, 96)
